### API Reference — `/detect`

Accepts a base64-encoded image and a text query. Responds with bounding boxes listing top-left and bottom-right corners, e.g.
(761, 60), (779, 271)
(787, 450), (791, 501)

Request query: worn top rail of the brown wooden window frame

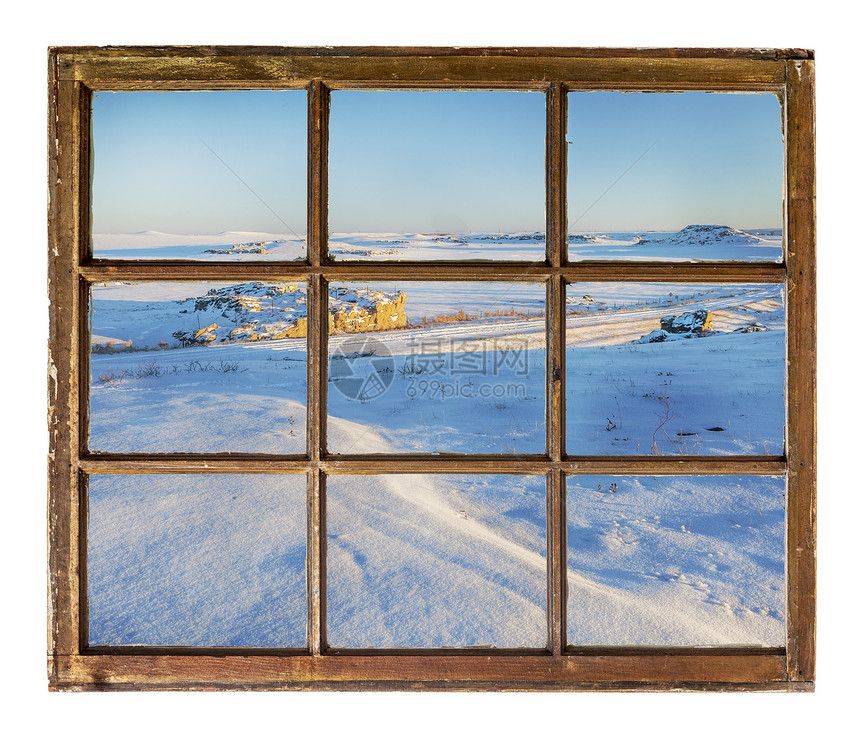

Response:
(58, 48), (784, 90)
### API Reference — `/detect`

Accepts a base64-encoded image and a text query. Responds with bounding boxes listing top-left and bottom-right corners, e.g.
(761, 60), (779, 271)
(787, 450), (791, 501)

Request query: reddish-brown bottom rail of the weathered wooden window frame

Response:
(52, 651), (787, 690)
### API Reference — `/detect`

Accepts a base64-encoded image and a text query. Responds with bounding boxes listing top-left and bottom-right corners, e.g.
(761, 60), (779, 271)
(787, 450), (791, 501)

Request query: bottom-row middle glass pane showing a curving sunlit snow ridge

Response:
(327, 475), (547, 648)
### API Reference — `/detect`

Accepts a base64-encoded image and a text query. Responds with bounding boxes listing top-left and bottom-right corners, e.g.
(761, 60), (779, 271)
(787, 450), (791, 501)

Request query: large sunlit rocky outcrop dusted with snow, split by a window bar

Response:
(173, 282), (407, 346)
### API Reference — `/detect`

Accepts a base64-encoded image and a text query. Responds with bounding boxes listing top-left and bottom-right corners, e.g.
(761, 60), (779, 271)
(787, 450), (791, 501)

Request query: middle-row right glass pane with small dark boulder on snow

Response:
(567, 282), (785, 455)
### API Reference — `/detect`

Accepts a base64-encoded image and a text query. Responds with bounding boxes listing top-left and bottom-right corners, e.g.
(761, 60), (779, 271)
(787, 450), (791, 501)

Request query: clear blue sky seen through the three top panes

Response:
(93, 90), (782, 233)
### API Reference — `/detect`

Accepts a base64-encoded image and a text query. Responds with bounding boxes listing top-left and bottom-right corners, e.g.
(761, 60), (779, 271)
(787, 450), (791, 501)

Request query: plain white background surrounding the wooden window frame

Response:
(0, 0), (860, 736)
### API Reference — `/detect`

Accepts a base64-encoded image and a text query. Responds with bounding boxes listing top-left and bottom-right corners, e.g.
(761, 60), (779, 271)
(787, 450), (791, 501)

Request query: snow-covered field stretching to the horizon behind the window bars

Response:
(88, 227), (785, 648)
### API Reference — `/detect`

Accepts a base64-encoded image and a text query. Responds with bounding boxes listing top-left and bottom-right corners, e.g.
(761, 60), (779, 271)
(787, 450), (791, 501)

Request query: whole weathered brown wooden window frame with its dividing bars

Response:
(48, 47), (816, 691)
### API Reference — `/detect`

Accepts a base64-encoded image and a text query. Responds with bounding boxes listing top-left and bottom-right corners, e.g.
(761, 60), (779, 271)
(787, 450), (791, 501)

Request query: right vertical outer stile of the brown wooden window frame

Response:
(785, 61), (816, 681)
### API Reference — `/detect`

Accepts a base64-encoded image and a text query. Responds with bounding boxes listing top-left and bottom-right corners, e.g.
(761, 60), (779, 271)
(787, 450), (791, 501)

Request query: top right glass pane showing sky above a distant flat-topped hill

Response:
(568, 92), (783, 261)
